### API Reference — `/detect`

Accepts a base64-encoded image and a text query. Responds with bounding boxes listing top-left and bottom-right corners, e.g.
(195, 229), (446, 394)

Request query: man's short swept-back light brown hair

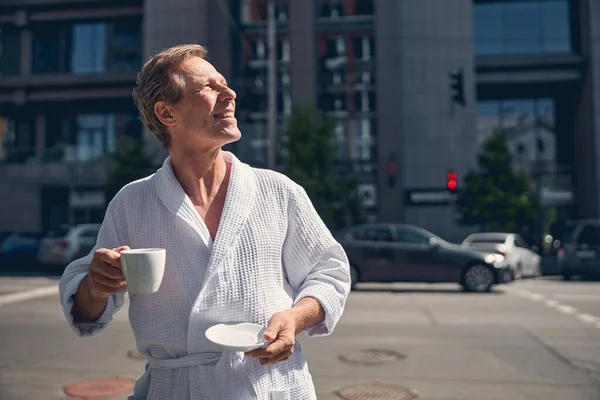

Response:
(133, 44), (208, 148)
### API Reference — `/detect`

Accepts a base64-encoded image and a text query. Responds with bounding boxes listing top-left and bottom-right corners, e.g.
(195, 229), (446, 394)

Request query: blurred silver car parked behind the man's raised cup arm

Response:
(38, 224), (100, 267)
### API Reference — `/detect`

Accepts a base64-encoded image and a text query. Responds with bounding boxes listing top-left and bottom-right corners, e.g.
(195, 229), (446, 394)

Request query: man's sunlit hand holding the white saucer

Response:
(246, 310), (296, 365)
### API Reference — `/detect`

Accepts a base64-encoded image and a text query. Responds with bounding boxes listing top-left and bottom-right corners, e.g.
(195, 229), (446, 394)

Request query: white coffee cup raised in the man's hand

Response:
(121, 249), (167, 294)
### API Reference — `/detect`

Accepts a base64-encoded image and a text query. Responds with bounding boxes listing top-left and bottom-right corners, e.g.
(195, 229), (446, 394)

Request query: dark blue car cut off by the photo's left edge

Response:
(0, 232), (39, 270)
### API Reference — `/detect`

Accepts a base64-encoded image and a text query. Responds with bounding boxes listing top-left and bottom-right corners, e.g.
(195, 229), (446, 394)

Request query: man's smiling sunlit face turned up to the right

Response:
(167, 57), (241, 153)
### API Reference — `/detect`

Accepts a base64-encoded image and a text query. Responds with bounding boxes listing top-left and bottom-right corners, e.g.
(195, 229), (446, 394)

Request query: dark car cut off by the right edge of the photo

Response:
(557, 220), (600, 280)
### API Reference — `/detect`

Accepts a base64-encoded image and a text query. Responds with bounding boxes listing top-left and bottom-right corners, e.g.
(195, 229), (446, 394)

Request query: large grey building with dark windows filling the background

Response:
(0, 0), (600, 239)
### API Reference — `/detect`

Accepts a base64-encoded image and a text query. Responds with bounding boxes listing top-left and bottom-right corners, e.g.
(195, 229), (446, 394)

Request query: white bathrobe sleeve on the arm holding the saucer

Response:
(282, 185), (350, 337)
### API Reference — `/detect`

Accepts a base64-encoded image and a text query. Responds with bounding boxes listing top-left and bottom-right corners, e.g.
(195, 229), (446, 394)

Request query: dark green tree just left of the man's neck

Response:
(106, 139), (157, 199)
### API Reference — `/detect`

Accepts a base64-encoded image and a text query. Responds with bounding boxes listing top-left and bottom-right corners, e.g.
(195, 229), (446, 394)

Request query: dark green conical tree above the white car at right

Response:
(456, 130), (537, 232)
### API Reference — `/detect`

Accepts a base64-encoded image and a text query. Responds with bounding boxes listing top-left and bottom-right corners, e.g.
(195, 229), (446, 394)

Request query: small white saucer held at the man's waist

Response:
(204, 322), (269, 352)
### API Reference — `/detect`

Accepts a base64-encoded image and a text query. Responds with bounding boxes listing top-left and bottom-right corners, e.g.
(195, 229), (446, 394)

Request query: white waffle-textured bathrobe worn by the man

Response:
(60, 152), (350, 400)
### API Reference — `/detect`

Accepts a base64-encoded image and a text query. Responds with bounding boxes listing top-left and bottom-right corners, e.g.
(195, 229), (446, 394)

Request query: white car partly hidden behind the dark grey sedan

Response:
(462, 233), (542, 278)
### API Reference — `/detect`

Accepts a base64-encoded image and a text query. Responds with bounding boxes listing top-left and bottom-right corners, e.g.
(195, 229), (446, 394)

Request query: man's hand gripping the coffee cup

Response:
(86, 246), (129, 299)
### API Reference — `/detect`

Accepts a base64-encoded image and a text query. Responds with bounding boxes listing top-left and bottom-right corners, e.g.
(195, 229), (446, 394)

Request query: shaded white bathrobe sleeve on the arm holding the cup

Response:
(59, 203), (125, 337)
